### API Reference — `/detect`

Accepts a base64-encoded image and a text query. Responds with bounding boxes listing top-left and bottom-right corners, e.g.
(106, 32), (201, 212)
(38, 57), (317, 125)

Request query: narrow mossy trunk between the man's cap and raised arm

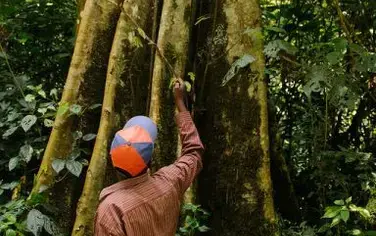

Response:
(150, 0), (192, 169)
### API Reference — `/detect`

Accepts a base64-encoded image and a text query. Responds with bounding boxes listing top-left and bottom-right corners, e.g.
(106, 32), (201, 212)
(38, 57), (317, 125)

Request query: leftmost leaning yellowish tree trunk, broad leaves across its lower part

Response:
(31, 0), (122, 231)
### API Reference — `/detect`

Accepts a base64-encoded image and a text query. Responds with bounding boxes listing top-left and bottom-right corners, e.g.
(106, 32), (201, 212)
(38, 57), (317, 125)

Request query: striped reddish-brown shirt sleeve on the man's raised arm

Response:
(156, 112), (204, 195)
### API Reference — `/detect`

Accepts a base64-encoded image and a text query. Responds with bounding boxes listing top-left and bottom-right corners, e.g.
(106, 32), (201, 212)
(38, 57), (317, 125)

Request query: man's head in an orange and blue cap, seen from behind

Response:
(111, 116), (157, 177)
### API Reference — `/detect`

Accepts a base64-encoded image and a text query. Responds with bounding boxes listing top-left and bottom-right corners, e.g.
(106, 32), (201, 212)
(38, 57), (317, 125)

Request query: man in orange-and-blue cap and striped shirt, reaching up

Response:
(95, 82), (204, 236)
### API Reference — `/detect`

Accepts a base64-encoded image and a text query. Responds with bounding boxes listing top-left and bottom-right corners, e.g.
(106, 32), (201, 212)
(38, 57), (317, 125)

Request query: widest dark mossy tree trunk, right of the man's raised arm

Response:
(196, 0), (278, 236)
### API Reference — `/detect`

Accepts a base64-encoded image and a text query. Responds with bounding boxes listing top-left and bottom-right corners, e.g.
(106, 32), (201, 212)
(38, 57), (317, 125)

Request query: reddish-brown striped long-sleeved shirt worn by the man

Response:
(94, 112), (204, 236)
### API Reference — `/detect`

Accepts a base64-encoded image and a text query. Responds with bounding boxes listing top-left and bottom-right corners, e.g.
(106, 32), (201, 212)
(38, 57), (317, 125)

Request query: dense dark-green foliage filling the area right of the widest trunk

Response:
(262, 0), (376, 235)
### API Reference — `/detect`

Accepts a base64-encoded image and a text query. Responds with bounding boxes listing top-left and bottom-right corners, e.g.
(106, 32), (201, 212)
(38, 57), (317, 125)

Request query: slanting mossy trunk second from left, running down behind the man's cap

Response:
(72, 0), (153, 235)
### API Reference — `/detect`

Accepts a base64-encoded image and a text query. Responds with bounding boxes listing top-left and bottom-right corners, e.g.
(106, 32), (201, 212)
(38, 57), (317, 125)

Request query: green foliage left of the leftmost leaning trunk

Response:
(0, 0), (77, 235)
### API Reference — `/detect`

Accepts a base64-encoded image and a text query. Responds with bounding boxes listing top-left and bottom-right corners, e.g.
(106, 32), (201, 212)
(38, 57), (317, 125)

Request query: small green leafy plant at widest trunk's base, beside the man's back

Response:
(176, 203), (210, 236)
